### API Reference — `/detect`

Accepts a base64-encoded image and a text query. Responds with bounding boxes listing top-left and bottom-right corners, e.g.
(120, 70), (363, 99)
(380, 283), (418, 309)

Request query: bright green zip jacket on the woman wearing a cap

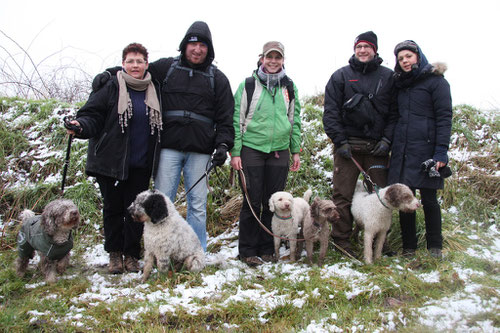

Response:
(231, 73), (302, 156)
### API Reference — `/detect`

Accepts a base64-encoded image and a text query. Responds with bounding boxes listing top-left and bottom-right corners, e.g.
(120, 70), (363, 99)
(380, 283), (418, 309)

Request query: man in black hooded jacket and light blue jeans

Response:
(93, 21), (234, 250)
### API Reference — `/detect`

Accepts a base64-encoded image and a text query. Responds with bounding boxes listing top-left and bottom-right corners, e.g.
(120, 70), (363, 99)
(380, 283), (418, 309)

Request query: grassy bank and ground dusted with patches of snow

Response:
(0, 96), (500, 332)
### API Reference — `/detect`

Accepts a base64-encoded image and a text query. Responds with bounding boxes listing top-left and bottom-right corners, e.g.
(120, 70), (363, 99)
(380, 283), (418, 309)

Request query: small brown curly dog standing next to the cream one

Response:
(300, 197), (340, 266)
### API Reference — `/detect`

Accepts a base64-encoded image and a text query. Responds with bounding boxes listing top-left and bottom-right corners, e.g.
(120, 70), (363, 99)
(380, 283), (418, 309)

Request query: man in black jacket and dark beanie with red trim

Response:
(323, 31), (398, 255)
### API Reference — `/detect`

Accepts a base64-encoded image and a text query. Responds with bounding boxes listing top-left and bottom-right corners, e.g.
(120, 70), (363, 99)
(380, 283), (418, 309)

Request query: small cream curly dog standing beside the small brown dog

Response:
(269, 190), (312, 261)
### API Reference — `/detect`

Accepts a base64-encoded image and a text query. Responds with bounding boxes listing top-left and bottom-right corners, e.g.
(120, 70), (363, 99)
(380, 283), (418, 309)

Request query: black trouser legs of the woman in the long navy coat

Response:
(399, 188), (443, 249)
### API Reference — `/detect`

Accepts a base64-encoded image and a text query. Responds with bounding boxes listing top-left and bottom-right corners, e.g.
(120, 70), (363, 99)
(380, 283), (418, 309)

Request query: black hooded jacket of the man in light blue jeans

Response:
(149, 21), (234, 154)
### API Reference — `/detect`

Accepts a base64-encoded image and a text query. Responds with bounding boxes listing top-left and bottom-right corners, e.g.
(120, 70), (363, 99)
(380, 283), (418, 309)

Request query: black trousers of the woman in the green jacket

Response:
(238, 147), (290, 257)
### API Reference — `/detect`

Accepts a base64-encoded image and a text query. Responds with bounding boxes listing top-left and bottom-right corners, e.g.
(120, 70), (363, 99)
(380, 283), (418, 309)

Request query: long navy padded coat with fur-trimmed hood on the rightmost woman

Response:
(388, 65), (452, 189)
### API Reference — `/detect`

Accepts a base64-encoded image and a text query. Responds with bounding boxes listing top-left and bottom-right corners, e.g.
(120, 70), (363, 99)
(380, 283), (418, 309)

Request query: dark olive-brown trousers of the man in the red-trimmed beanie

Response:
(332, 152), (388, 248)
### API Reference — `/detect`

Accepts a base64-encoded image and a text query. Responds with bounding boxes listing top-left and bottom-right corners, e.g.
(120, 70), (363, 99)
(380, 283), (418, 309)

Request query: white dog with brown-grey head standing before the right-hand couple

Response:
(351, 181), (420, 264)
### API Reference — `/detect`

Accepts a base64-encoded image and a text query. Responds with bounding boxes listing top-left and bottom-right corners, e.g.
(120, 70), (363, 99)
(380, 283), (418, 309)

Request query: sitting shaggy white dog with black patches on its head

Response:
(129, 190), (205, 281)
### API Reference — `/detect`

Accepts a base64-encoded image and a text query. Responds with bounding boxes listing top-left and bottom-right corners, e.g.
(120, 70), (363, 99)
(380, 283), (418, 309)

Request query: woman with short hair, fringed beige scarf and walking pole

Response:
(68, 43), (162, 274)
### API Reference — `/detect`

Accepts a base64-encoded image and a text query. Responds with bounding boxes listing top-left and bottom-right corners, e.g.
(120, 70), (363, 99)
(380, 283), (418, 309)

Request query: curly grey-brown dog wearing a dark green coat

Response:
(16, 199), (80, 283)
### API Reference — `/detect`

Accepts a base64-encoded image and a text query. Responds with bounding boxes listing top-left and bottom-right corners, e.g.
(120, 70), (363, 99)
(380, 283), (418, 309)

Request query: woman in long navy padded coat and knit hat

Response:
(388, 40), (452, 258)
